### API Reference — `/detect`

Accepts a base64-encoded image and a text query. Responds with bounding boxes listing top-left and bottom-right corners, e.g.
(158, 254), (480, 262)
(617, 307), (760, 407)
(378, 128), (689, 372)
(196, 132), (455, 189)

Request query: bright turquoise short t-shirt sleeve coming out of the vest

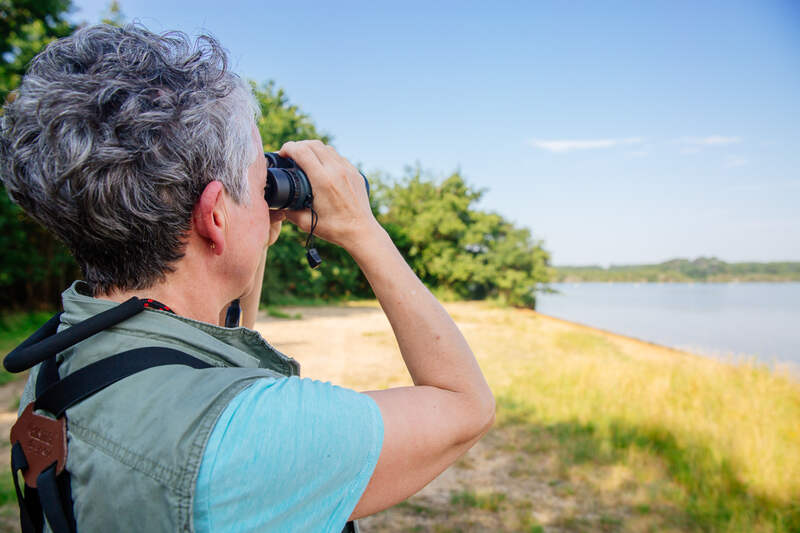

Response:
(194, 377), (383, 533)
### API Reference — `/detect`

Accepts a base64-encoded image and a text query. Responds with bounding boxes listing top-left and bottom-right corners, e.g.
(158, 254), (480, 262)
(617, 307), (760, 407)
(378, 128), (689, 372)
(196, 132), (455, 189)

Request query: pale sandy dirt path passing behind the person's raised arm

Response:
(256, 303), (620, 533)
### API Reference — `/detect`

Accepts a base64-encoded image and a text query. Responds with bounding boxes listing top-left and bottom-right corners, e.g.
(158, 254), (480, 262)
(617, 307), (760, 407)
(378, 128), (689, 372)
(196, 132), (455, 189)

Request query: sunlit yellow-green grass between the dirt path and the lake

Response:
(456, 308), (800, 532)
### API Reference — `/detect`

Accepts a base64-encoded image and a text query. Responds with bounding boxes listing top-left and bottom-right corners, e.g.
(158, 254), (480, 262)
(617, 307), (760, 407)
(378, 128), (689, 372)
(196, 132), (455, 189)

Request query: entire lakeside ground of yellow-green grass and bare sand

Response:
(0, 303), (800, 533)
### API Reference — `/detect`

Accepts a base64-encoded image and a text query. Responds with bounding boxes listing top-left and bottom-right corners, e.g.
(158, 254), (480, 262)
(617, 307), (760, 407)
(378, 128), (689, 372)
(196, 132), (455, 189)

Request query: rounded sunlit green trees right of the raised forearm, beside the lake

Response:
(376, 168), (549, 308)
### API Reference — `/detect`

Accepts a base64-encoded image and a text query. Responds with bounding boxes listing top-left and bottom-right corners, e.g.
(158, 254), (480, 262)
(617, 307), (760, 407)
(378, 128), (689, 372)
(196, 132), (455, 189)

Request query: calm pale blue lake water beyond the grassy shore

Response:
(536, 283), (800, 364)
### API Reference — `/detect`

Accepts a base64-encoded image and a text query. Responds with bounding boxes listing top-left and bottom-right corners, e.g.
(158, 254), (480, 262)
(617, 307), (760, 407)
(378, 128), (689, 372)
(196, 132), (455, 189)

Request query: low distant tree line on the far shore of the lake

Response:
(554, 257), (800, 282)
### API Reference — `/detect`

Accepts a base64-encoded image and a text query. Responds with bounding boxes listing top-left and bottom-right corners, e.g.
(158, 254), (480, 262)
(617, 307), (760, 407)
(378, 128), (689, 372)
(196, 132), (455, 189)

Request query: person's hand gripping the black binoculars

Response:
(278, 140), (380, 251)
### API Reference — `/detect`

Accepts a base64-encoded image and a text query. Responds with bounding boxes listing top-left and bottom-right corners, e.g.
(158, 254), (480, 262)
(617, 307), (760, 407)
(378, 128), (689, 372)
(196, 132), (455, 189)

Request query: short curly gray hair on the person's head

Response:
(0, 25), (260, 294)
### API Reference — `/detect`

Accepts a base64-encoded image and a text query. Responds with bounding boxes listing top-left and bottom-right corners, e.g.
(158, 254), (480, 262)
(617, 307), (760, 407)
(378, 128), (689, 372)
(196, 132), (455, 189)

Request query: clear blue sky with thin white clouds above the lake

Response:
(71, 0), (800, 265)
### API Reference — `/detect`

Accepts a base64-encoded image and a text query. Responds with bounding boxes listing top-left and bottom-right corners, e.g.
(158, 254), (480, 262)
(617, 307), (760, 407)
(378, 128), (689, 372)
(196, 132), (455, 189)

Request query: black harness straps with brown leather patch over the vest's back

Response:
(3, 298), (359, 533)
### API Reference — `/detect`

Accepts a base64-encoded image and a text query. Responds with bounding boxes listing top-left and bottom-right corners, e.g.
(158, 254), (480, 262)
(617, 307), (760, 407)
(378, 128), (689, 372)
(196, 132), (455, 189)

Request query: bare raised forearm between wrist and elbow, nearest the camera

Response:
(349, 225), (494, 413)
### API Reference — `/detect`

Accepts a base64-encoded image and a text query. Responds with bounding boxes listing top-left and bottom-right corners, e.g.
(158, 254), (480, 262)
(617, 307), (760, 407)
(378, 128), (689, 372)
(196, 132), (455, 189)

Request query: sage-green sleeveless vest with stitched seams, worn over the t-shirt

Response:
(20, 282), (300, 533)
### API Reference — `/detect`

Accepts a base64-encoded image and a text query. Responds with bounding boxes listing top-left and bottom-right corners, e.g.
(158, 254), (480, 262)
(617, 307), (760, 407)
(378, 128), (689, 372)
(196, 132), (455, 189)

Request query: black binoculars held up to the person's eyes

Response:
(264, 152), (369, 210)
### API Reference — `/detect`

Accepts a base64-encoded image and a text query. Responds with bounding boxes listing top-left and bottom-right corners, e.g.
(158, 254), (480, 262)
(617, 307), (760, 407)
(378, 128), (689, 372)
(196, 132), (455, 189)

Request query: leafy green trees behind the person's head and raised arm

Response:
(0, 4), (550, 309)
